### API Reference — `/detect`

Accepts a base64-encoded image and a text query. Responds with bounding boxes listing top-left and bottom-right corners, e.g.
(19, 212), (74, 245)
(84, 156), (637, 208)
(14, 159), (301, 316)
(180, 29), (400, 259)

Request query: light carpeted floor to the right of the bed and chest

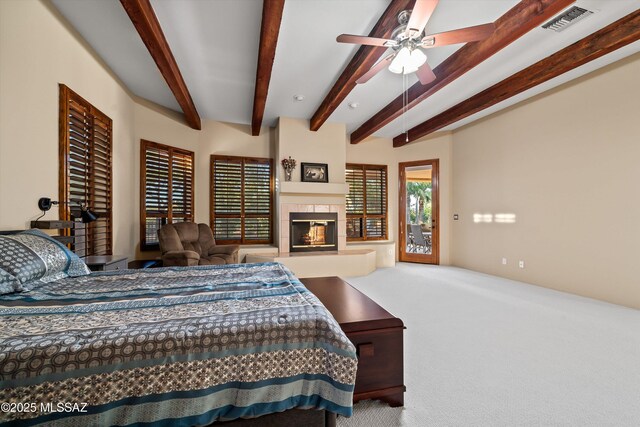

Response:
(338, 263), (640, 427)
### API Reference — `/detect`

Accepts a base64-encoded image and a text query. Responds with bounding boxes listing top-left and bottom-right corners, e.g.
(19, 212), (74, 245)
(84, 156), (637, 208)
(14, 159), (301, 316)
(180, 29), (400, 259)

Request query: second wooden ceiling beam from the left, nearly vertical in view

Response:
(251, 0), (284, 136)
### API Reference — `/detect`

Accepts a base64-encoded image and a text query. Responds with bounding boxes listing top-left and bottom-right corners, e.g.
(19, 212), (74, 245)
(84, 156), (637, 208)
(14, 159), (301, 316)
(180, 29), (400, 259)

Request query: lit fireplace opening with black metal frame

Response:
(289, 212), (338, 252)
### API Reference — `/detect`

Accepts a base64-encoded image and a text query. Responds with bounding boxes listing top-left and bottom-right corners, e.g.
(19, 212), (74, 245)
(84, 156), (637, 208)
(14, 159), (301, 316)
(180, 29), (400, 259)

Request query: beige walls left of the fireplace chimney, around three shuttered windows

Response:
(0, 0), (274, 259)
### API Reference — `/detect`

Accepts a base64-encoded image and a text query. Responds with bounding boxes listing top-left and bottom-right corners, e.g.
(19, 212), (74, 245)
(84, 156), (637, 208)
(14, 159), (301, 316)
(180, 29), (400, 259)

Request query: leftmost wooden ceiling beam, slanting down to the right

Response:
(120, 0), (202, 130)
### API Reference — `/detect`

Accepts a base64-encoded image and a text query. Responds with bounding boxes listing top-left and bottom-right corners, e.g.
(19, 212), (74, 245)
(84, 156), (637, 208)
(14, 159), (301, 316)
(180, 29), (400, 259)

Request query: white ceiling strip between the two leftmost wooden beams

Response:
(151, 0), (262, 123)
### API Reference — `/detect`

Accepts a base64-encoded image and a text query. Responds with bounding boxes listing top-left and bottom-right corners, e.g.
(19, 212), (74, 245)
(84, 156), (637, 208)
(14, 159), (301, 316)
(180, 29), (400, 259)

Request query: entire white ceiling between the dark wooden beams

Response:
(52, 0), (640, 137)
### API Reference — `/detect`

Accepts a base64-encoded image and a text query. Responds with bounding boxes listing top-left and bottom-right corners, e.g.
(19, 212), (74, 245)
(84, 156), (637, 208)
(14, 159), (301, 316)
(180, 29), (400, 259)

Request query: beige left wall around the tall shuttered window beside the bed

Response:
(0, 0), (137, 254)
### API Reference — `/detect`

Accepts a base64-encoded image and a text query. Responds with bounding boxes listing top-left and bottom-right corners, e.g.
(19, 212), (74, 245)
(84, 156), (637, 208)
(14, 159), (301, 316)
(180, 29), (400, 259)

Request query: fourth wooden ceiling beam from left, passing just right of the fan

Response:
(351, 0), (575, 144)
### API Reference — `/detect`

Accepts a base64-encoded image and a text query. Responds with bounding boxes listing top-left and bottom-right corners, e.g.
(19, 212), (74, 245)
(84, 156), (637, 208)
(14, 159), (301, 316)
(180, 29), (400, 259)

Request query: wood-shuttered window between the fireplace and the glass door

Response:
(346, 163), (387, 241)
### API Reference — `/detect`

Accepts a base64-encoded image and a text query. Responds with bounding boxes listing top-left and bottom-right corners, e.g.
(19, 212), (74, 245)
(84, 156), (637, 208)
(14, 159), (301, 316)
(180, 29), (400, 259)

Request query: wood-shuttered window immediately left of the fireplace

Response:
(210, 155), (274, 244)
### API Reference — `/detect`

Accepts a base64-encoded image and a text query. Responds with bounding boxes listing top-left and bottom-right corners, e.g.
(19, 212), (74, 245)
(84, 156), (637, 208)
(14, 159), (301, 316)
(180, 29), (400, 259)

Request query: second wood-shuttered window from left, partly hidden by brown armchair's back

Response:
(140, 139), (194, 250)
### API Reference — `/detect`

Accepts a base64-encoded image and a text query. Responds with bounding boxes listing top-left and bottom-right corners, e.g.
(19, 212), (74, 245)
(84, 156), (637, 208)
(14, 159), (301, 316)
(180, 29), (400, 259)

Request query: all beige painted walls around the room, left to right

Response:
(0, 0), (640, 308)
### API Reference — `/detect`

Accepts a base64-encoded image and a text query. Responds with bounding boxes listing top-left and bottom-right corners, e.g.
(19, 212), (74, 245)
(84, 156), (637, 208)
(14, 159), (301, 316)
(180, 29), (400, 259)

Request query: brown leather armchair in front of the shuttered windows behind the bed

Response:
(158, 222), (240, 267)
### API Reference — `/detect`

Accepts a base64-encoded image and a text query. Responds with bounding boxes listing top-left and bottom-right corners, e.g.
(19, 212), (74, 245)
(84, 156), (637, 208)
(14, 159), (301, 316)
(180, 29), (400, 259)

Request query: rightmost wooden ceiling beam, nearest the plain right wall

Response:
(393, 10), (640, 147)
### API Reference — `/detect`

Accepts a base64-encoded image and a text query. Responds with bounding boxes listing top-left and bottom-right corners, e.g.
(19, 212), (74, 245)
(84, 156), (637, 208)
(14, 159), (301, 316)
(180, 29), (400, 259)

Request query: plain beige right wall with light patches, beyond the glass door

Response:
(452, 54), (640, 308)
